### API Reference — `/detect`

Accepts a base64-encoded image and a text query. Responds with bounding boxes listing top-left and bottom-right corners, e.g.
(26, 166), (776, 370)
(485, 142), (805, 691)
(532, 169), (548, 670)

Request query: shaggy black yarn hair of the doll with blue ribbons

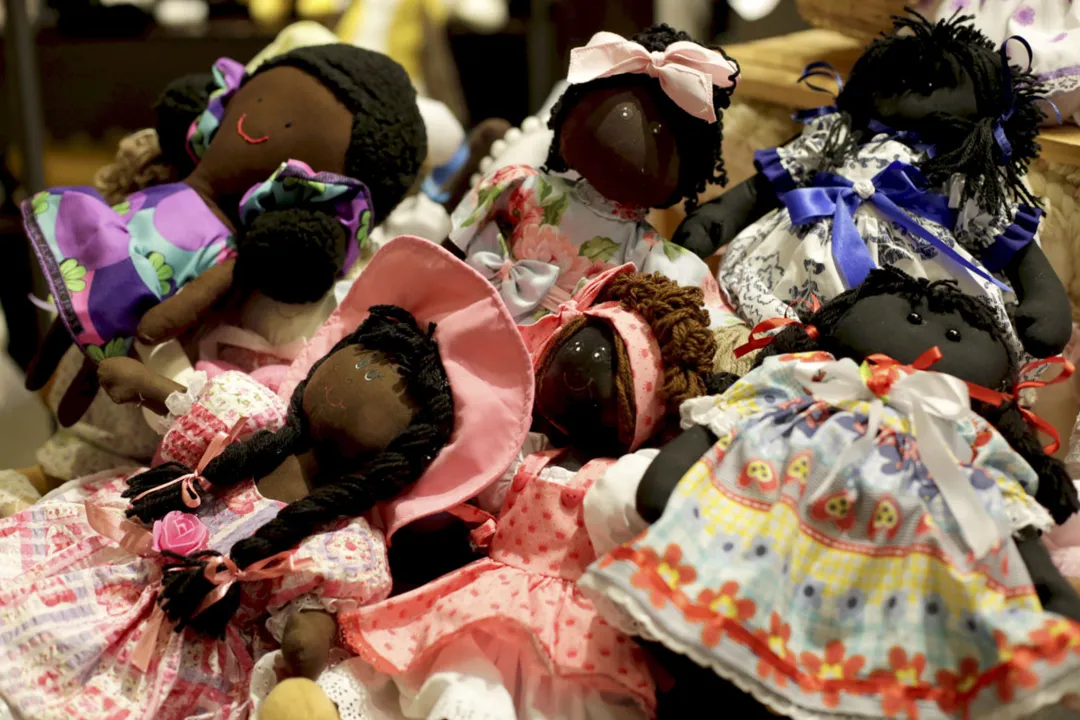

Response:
(821, 8), (1045, 213)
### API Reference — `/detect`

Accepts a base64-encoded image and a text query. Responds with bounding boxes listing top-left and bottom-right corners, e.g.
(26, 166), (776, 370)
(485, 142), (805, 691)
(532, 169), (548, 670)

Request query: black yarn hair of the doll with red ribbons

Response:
(754, 267), (1080, 524)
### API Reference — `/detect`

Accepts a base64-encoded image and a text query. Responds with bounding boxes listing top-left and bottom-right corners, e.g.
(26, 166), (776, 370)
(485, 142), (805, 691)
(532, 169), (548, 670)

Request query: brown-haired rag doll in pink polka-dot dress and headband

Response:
(262, 264), (715, 720)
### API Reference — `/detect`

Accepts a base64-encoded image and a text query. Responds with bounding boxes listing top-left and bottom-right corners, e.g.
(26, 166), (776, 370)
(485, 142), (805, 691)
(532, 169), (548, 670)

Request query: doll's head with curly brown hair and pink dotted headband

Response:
(522, 264), (716, 456)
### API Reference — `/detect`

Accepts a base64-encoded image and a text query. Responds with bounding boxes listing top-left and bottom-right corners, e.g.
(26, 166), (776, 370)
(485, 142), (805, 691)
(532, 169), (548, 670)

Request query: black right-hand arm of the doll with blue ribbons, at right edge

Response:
(1004, 241), (1072, 357)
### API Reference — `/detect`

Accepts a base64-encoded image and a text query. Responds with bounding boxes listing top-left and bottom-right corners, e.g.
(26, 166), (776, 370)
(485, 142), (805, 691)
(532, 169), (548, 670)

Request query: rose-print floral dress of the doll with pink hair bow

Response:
(450, 165), (730, 325)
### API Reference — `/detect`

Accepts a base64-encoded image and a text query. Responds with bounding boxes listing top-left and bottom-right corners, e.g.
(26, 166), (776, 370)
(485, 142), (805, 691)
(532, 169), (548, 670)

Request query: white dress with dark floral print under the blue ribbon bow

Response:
(718, 113), (1038, 362)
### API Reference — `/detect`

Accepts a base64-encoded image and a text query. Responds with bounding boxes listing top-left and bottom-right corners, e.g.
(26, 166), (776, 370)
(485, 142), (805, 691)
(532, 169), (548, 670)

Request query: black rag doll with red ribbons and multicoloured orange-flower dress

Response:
(582, 270), (1080, 718)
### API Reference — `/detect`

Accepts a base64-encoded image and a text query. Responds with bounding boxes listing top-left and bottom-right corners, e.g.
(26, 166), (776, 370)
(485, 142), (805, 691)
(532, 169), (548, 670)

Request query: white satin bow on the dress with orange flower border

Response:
(795, 358), (1000, 558)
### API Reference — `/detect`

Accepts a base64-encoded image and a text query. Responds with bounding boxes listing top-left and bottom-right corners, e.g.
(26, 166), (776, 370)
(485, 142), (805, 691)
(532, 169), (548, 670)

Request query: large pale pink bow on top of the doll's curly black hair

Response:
(566, 32), (739, 123)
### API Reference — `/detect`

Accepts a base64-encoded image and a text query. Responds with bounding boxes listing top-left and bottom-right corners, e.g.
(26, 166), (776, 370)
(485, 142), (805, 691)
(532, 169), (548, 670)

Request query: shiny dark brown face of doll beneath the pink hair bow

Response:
(556, 86), (679, 207)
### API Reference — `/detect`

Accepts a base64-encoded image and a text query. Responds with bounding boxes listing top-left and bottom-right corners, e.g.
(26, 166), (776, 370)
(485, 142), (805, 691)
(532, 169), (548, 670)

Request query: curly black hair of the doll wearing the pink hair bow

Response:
(544, 24), (739, 212)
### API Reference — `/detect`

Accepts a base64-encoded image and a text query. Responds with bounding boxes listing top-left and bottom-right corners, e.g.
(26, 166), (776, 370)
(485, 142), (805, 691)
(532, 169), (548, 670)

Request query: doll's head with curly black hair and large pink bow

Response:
(548, 25), (739, 208)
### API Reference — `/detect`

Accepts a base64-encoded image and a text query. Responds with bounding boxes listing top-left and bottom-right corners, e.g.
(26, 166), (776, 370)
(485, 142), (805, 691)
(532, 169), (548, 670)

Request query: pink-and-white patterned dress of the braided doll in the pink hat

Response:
(0, 377), (391, 720)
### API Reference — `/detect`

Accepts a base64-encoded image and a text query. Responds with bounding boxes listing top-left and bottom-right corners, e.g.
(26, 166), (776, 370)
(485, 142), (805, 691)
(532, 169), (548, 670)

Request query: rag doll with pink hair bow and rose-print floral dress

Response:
(449, 25), (739, 324)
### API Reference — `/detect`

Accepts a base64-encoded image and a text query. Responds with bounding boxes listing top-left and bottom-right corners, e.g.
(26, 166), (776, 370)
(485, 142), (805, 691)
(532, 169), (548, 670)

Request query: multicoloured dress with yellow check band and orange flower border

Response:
(580, 356), (1080, 719)
